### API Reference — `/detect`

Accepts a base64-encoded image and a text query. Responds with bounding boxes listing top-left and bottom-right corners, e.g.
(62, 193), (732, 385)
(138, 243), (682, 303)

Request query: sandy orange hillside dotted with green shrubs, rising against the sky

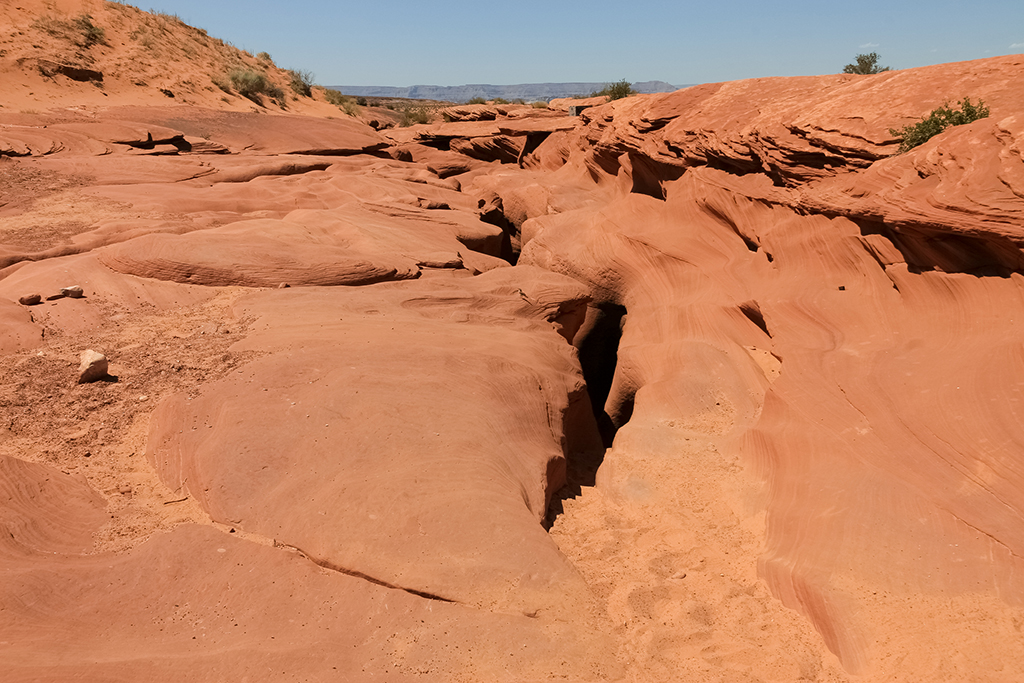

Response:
(0, 0), (348, 116)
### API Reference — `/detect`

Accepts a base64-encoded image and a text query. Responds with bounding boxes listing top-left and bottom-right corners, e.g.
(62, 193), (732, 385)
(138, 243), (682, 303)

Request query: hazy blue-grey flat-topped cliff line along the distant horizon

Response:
(328, 81), (686, 102)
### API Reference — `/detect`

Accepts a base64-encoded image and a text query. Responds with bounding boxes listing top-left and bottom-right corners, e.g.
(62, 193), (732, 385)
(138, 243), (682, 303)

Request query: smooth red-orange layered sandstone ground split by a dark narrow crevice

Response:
(0, 0), (1024, 682)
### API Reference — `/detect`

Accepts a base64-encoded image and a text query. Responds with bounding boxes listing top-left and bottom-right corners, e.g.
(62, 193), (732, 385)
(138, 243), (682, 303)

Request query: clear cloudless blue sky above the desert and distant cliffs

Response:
(141, 0), (1024, 86)
